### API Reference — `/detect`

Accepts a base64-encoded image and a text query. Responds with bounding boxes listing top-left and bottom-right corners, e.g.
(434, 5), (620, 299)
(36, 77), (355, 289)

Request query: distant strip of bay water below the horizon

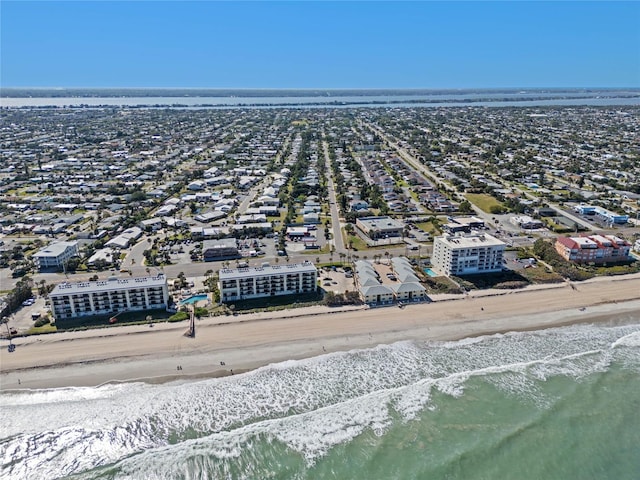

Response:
(0, 89), (640, 108)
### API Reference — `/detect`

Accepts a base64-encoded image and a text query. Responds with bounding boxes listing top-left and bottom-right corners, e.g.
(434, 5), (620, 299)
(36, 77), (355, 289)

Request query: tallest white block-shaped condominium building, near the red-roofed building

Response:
(431, 233), (506, 276)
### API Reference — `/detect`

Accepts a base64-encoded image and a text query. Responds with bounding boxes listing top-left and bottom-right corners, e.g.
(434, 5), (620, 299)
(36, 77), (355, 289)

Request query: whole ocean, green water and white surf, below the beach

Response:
(0, 318), (640, 480)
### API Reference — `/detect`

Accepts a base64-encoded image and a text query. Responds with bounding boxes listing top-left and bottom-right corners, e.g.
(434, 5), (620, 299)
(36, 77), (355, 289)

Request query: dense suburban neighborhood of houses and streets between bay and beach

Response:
(0, 106), (640, 334)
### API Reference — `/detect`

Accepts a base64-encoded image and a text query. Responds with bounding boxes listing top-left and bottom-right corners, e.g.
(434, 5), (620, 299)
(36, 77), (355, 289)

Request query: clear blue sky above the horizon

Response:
(0, 0), (640, 88)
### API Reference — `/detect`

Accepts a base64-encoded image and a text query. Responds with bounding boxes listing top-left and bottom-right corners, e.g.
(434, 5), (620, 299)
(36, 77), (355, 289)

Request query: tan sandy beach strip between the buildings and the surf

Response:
(0, 275), (640, 390)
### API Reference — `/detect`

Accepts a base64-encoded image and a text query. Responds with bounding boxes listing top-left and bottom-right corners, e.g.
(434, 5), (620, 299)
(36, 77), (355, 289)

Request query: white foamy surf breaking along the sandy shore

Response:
(0, 325), (640, 478)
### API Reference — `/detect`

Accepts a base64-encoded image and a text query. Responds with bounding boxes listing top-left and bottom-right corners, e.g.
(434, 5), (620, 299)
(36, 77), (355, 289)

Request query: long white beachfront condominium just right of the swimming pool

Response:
(218, 261), (318, 303)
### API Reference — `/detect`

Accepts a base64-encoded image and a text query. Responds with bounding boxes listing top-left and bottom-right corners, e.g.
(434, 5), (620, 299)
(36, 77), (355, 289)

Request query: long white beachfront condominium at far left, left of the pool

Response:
(49, 275), (169, 321)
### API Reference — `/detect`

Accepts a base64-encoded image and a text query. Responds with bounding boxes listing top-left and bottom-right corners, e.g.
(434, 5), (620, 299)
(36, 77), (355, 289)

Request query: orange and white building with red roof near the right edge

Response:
(555, 235), (631, 263)
